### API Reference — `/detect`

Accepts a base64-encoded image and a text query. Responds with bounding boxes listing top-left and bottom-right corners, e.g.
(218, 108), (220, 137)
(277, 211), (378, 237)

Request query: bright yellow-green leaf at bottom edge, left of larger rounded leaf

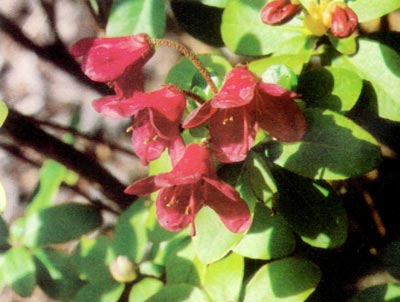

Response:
(204, 253), (244, 301)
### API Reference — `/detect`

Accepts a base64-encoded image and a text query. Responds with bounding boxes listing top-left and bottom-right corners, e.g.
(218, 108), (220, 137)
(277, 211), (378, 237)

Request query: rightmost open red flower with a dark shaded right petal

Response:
(183, 66), (306, 163)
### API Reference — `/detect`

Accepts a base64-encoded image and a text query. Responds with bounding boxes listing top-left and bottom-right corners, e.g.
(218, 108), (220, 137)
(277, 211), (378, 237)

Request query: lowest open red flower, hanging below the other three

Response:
(125, 144), (251, 236)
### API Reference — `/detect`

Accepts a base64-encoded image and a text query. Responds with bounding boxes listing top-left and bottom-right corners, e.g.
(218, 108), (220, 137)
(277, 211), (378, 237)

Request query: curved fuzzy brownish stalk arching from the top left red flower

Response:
(151, 39), (218, 94)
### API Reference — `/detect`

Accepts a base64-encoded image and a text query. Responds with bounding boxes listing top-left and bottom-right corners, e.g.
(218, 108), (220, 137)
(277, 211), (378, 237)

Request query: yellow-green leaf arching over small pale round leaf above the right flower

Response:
(248, 53), (311, 77)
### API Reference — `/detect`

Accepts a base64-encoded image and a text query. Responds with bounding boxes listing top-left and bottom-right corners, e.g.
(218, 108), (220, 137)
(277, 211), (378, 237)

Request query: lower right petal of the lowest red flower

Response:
(203, 177), (251, 233)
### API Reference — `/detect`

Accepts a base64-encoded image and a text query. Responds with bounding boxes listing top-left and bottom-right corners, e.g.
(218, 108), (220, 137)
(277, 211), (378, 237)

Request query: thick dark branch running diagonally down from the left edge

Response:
(1, 109), (136, 210)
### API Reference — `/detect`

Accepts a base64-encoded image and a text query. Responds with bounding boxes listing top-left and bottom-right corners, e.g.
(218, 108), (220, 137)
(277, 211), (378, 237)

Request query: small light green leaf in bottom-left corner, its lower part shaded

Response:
(2, 247), (36, 297)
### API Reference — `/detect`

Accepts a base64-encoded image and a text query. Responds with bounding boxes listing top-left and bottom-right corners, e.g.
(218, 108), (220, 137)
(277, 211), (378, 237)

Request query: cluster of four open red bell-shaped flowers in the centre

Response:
(71, 34), (306, 235)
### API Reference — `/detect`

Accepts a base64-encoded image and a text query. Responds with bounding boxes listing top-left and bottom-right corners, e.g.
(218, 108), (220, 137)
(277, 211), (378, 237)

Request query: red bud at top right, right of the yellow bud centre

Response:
(331, 5), (358, 38)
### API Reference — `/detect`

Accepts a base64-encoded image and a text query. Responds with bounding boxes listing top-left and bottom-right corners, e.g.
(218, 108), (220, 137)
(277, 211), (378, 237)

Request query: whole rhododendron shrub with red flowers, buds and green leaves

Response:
(0, 0), (400, 302)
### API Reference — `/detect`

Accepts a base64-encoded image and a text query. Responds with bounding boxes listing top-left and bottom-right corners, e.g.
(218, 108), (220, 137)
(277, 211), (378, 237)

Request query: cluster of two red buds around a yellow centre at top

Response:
(261, 0), (358, 38)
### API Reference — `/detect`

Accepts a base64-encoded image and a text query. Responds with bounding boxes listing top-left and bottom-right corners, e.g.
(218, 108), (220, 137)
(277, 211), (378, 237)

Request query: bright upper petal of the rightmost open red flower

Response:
(211, 66), (258, 108)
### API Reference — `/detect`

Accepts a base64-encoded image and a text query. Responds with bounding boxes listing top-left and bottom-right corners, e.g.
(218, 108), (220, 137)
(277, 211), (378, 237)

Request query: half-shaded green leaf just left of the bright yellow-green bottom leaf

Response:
(165, 238), (206, 286)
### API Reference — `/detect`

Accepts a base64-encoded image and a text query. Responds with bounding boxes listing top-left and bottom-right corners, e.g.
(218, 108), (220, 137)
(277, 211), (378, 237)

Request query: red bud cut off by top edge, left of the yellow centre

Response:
(261, 0), (301, 25)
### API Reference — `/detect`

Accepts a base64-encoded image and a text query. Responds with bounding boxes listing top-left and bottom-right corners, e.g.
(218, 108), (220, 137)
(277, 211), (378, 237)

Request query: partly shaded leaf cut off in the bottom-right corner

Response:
(351, 283), (400, 302)
